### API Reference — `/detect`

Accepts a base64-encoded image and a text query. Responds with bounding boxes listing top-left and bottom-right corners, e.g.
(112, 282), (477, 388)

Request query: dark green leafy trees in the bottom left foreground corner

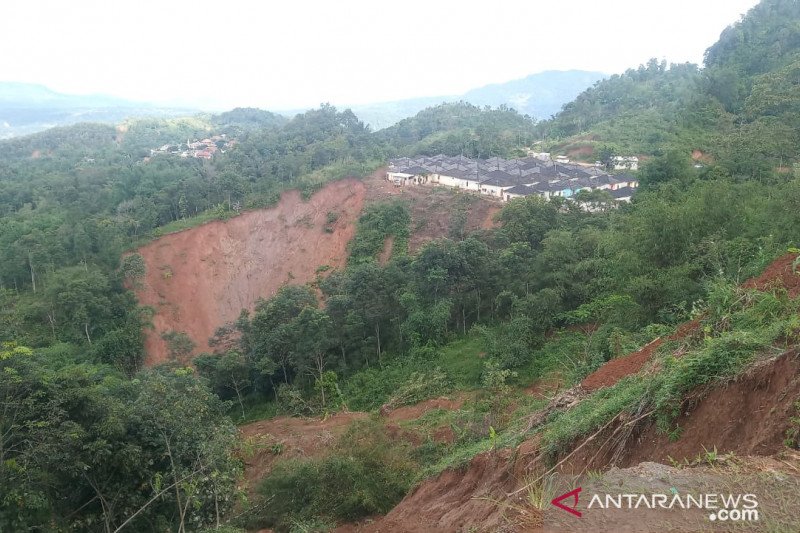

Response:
(0, 346), (240, 531)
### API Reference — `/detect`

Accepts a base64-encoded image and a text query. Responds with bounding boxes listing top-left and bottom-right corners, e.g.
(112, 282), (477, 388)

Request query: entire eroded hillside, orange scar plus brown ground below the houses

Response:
(137, 169), (500, 365)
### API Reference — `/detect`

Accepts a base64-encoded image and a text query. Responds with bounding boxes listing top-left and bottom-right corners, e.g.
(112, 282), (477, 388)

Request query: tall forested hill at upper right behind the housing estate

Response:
(539, 0), (800, 177)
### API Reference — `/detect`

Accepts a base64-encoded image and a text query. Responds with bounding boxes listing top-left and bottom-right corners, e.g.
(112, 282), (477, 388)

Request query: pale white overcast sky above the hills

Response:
(0, 0), (757, 110)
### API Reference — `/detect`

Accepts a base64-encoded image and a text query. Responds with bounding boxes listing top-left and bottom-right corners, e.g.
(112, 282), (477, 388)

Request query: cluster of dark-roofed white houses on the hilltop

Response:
(386, 154), (639, 202)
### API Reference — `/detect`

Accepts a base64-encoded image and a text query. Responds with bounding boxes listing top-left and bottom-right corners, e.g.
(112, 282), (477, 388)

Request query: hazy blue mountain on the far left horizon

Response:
(0, 82), (195, 139)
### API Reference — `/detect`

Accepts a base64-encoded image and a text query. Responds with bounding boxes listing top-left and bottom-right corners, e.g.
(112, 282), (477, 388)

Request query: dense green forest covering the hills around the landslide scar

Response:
(0, 0), (800, 531)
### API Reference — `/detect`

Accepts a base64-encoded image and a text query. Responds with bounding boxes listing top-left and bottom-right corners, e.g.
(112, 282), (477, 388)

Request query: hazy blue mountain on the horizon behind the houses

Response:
(350, 70), (606, 129)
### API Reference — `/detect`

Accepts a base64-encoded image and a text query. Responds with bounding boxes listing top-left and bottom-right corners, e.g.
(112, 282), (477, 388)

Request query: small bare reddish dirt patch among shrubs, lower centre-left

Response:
(239, 412), (367, 490)
